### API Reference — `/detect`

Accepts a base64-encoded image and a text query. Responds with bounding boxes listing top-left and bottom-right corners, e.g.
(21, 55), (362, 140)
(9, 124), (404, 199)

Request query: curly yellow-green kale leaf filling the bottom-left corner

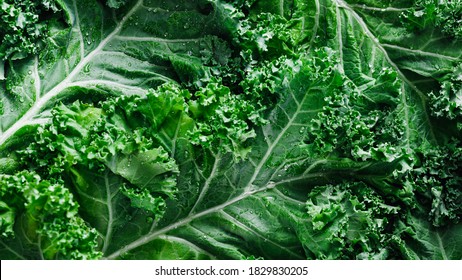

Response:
(0, 171), (101, 259)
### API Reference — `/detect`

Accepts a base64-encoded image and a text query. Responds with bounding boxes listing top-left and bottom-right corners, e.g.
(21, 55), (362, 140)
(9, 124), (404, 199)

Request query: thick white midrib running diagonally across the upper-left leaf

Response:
(0, 0), (143, 146)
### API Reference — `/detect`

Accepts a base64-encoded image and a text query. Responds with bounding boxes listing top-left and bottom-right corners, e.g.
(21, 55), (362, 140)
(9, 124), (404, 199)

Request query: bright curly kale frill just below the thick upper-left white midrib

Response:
(18, 89), (182, 219)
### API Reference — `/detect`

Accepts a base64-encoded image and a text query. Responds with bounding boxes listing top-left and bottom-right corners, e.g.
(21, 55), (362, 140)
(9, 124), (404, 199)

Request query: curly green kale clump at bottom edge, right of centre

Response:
(306, 183), (401, 259)
